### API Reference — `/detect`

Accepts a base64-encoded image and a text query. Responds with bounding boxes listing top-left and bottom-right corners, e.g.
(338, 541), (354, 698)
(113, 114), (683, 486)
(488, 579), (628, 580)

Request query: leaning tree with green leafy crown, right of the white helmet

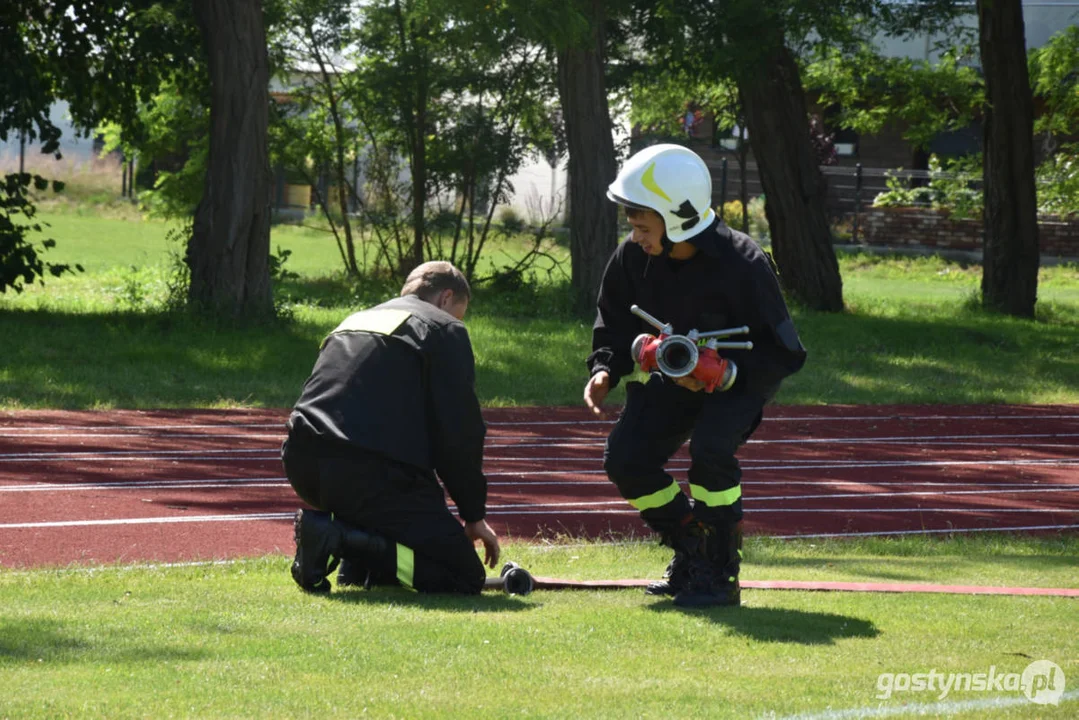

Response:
(634, 0), (956, 311)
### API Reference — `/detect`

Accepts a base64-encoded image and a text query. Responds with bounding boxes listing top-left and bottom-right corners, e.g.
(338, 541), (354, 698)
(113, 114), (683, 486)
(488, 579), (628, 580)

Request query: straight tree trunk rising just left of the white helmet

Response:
(558, 0), (618, 313)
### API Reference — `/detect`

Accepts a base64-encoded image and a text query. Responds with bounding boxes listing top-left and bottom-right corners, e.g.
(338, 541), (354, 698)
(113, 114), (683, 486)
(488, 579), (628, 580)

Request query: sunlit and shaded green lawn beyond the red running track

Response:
(0, 213), (1079, 409)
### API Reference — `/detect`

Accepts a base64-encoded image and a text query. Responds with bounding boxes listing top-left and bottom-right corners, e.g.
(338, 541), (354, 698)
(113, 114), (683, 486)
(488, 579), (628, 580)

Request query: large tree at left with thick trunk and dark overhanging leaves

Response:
(0, 0), (273, 317)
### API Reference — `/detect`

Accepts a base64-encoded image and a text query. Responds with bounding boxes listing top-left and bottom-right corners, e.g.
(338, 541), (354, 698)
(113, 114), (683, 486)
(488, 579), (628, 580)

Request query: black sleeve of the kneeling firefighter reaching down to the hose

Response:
(428, 323), (487, 522)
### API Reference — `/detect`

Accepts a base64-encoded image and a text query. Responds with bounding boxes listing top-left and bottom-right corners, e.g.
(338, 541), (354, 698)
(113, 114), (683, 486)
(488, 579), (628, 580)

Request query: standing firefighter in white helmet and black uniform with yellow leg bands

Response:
(585, 145), (806, 607)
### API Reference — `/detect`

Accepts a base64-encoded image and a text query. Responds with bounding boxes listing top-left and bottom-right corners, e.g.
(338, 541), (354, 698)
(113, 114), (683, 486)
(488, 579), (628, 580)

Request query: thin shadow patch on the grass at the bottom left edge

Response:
(0, 619), (206, 666)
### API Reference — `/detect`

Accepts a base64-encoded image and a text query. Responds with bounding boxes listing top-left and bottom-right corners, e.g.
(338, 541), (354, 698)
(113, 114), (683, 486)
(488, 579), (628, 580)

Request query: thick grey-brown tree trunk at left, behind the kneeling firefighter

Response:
(186, 0), (273, 320)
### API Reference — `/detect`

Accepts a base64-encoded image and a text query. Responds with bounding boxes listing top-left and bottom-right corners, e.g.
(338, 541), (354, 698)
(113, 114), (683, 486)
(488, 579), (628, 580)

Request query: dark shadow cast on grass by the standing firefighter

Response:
(650, 601), (880, 646)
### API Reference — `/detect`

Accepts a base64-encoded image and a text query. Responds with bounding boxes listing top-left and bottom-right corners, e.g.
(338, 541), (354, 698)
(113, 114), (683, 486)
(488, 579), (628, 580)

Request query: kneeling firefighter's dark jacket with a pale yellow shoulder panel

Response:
(288, 295), (487, 522)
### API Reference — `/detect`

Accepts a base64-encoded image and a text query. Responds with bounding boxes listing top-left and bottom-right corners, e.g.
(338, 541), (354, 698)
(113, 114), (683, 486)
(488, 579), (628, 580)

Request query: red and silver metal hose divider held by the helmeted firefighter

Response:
(629, 305), (753, 393)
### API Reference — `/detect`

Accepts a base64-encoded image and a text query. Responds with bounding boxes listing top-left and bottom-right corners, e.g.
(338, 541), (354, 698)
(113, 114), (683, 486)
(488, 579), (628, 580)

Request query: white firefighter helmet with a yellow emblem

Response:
(607, 145), (715, 243)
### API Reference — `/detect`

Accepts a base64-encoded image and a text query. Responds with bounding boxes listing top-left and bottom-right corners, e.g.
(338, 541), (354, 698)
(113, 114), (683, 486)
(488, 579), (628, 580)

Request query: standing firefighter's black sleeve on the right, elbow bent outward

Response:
(720, 258), (806, 392)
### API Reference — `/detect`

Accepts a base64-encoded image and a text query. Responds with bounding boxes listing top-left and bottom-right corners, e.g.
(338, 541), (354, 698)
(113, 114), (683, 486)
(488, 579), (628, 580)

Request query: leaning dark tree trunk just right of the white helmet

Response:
(738, 43), (843, 312)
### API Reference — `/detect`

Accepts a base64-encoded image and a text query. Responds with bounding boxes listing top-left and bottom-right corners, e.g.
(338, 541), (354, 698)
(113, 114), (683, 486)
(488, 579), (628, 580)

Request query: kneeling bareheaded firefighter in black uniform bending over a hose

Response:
(282, 262), (498, 593)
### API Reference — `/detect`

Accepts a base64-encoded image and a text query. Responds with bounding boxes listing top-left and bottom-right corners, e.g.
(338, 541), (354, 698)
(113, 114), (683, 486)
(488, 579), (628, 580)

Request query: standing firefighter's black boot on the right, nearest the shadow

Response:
(674, 522), (741, 608)
